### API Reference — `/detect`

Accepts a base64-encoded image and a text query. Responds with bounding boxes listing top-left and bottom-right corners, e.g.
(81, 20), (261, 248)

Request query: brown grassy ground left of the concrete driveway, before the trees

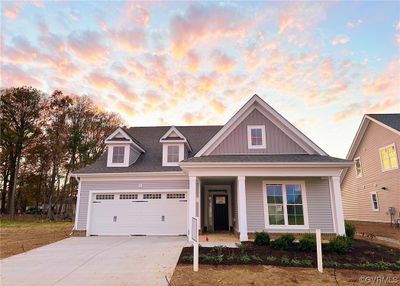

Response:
(0, 221), (73, 259)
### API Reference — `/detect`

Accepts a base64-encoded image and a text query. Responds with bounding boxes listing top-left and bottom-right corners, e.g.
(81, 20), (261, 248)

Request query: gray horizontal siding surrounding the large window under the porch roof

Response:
(246, 177), (335, 233)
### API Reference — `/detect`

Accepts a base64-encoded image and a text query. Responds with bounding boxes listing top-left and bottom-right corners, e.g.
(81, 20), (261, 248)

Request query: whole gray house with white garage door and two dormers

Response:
(74, 95), (352, 241)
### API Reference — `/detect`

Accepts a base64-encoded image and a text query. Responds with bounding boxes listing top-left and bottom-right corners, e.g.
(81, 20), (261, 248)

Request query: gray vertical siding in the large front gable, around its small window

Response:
(211, 109), (307, 155)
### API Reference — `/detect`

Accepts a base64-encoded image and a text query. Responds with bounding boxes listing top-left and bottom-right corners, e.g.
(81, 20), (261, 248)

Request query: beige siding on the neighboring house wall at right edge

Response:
(341, 122), (400, 223)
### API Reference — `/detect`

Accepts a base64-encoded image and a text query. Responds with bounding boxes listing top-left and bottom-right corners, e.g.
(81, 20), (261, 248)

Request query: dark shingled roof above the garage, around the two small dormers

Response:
(73, 126), (222, 174)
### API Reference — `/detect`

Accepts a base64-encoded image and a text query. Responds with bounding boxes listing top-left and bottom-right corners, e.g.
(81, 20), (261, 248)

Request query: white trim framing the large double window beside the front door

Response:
(262, 181), (309, 230)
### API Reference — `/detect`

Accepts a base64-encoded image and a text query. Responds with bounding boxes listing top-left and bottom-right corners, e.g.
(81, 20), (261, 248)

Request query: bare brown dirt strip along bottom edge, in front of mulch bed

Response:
(171, 265), (400, 286)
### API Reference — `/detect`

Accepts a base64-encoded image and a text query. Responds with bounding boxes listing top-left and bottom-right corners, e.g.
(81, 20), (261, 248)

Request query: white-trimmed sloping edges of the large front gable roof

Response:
(195, 94), (328, 157)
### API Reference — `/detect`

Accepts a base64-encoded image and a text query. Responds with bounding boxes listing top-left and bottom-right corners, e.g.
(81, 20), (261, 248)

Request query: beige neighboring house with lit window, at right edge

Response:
(342, 113), (400, 226)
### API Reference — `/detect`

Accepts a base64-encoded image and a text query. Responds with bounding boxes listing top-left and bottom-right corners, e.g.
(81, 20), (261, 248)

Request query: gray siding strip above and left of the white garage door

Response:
(77, 178), (189, 230)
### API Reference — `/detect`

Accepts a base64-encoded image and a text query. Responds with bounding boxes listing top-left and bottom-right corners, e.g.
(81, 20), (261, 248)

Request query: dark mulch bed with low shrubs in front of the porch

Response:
(179, 239), (400, 271)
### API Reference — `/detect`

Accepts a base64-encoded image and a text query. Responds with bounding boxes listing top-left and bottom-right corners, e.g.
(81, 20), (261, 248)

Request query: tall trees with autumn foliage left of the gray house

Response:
(0, 86), (121, 219)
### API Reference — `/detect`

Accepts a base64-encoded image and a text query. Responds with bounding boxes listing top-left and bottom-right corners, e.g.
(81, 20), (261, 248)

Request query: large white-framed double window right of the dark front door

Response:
(264, 182), (308, 227)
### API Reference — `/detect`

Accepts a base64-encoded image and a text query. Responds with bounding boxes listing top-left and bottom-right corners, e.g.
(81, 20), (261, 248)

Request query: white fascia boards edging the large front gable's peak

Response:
(195, 94), (328, 157)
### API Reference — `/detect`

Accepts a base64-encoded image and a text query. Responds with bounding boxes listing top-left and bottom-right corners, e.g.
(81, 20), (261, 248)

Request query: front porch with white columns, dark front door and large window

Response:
(188, 165), (345, 242)
